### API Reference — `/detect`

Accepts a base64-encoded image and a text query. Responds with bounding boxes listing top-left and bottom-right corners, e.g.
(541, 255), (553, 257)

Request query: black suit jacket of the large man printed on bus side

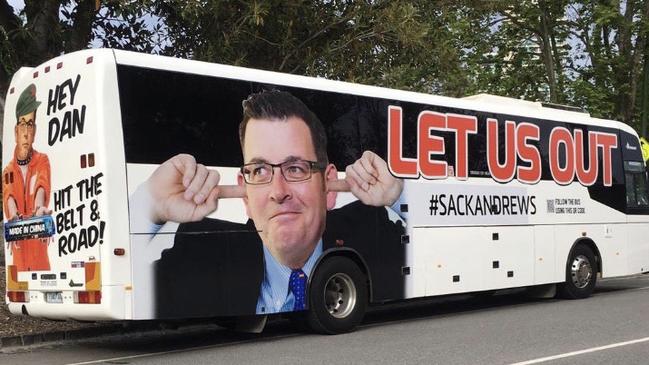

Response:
(155, 201), (405, 318)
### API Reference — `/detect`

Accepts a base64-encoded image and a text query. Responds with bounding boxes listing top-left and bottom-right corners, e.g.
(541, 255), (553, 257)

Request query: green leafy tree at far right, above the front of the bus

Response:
(570, 0), (649, 128)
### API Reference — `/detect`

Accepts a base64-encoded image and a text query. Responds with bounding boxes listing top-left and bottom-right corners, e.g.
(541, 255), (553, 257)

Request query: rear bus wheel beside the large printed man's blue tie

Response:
(307, 256), (367, 335)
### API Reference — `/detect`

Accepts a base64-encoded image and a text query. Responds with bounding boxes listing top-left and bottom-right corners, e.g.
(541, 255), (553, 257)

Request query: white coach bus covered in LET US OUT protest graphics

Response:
(2, 49), (649, 334)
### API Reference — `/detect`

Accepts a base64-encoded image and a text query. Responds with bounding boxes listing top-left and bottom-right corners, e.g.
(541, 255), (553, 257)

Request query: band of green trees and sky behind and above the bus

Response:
(0, 0), (649, 131)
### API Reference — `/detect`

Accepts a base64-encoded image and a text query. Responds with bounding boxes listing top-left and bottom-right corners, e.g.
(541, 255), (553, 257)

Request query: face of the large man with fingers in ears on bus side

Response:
(239, 117), (336, 268)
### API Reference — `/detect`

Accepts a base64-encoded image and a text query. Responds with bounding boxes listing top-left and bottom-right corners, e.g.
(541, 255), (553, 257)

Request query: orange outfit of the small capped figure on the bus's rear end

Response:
(2, 149), (50, 271)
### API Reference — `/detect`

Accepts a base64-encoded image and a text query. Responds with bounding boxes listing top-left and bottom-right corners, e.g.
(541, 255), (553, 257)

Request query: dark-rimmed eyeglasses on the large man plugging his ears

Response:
(241, 160), (325, 185)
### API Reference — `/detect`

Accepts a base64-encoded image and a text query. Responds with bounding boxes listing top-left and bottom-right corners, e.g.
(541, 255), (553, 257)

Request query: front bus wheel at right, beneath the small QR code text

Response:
(557, 245), (597, 299)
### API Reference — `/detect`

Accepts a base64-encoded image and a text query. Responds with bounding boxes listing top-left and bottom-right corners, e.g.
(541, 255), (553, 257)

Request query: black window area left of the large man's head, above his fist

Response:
(117, 66), (251, 167)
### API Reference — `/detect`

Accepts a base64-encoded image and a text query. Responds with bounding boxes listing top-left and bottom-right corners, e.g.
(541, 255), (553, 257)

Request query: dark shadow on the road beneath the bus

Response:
(22, 275), (649, 356)
